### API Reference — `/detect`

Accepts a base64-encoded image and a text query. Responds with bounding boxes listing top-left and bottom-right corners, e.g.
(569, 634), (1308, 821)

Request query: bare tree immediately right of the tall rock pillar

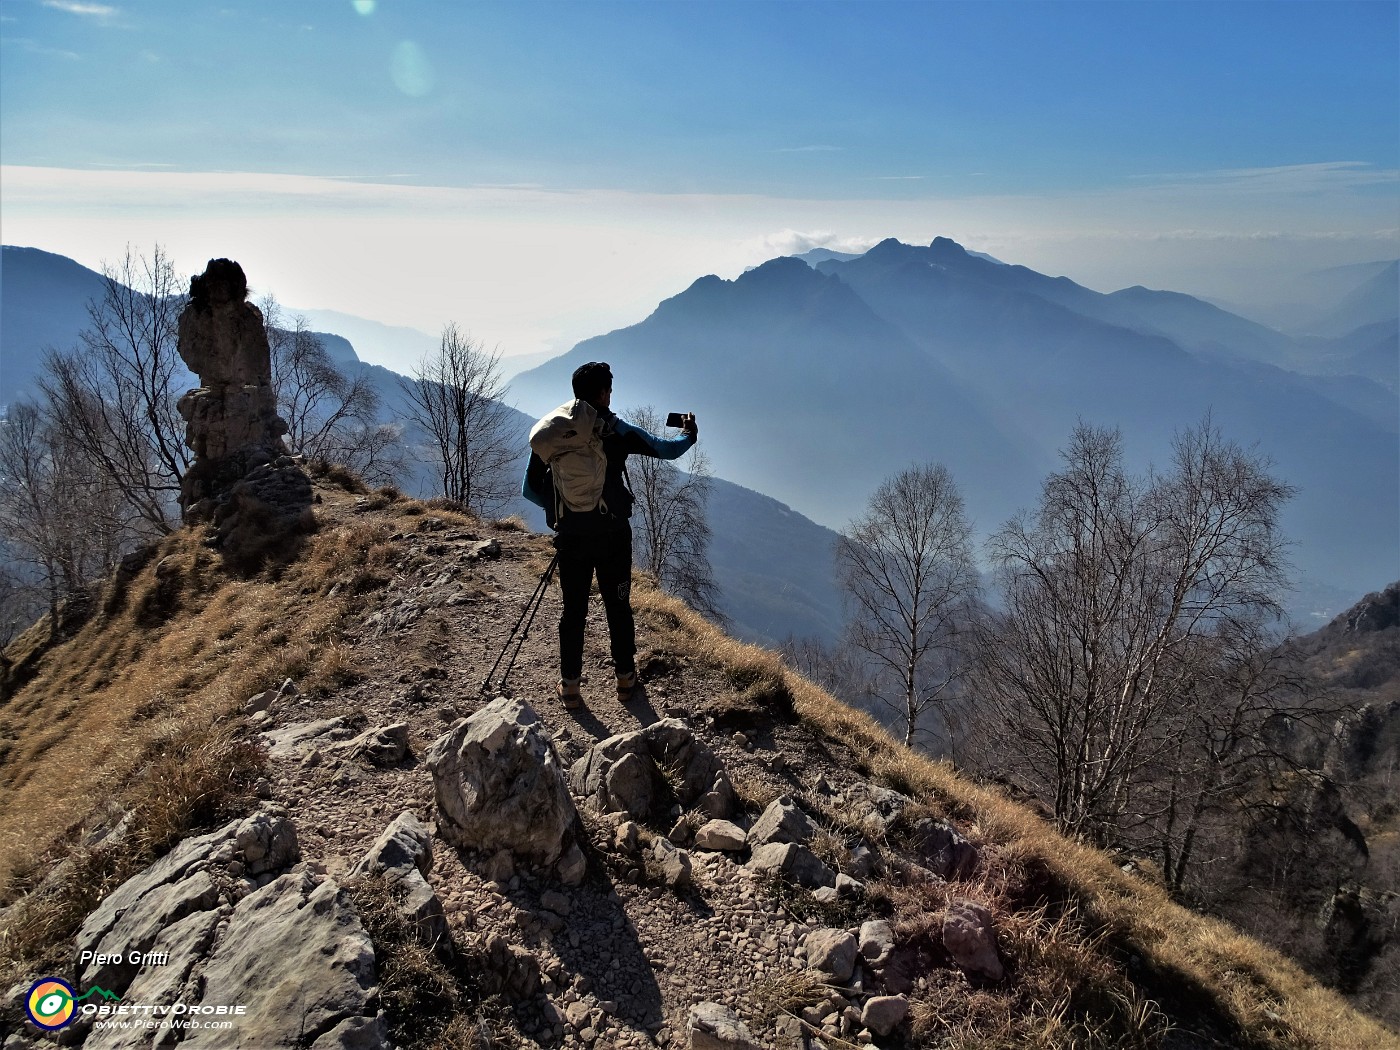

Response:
(258, 295), (403, 484)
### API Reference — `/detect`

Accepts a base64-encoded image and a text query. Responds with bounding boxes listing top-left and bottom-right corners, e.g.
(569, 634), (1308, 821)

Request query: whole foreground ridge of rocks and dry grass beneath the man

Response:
(0, 477), (1393, 1050)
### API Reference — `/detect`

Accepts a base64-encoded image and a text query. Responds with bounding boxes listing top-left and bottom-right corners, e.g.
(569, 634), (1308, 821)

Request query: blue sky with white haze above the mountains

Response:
(0, 0), (1400, 364)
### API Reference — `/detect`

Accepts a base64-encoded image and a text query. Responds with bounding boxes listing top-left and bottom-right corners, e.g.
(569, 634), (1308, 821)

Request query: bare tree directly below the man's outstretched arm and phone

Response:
(626, 405), (725, 623)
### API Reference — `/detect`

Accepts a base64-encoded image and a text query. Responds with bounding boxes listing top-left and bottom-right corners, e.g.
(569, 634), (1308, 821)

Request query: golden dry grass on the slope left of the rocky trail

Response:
(0, 491), (389, 925)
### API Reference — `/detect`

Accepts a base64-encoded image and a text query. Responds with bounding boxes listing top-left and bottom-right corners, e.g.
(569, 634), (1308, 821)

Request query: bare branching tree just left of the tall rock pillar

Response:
(39, 245), (192, 533)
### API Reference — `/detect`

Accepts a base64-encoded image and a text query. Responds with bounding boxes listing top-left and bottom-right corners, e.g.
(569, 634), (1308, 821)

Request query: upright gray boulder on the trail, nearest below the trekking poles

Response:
(427, 696), (578, 864)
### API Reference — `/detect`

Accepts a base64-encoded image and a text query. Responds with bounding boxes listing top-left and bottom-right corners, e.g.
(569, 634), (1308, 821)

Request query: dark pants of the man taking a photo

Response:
(554, 526), (637, 679)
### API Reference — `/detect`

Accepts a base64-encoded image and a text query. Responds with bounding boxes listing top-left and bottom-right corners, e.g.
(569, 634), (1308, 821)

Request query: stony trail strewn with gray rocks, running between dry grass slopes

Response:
(4, 494), (1002, 1050)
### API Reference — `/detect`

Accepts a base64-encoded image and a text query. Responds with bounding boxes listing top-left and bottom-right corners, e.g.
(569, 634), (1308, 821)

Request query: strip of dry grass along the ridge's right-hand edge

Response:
(634, 587), (1400, 1050)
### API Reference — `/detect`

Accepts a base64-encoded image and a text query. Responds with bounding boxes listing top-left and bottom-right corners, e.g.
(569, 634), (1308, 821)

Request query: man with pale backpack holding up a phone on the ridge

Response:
(521, 361), (699, 710)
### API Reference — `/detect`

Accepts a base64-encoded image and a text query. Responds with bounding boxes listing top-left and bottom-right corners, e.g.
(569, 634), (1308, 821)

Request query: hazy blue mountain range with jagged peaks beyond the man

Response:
(512, 238), (1400, 608)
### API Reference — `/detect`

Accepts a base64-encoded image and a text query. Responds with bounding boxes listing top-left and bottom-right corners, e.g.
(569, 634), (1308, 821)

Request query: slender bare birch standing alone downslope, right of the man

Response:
(836, 463), (977, 749)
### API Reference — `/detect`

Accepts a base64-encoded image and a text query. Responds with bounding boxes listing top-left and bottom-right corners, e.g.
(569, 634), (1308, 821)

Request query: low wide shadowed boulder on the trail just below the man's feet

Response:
(568, 718), (734, 820)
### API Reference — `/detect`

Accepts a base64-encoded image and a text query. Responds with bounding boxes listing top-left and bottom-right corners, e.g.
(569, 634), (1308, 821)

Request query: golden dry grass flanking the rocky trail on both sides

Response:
(0, 487), (1400, 1050)
